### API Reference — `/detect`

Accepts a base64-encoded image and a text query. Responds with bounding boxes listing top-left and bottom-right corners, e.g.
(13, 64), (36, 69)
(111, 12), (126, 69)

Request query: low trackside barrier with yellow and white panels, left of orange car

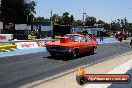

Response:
(0, 39), (59, 52)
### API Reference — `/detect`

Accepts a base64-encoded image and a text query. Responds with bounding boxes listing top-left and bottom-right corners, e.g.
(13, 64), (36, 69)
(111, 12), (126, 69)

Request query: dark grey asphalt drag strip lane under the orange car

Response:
(0, 43), (132, 88)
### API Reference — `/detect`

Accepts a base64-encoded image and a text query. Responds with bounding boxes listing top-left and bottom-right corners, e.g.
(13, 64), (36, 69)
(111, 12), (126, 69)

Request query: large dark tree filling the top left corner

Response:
(1, 0), (36, 23)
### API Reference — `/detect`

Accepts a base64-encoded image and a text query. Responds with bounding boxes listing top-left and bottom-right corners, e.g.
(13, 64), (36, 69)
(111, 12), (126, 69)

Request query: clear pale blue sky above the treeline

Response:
(34, 0), (132, 23)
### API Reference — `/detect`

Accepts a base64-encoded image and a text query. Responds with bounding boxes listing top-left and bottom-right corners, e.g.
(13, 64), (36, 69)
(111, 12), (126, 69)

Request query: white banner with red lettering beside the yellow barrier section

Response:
(15, 42), (38, 49)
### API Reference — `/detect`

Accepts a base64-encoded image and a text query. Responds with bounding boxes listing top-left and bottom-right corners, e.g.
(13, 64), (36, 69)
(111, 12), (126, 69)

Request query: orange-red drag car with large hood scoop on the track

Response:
(45, 34), (98, 58)
